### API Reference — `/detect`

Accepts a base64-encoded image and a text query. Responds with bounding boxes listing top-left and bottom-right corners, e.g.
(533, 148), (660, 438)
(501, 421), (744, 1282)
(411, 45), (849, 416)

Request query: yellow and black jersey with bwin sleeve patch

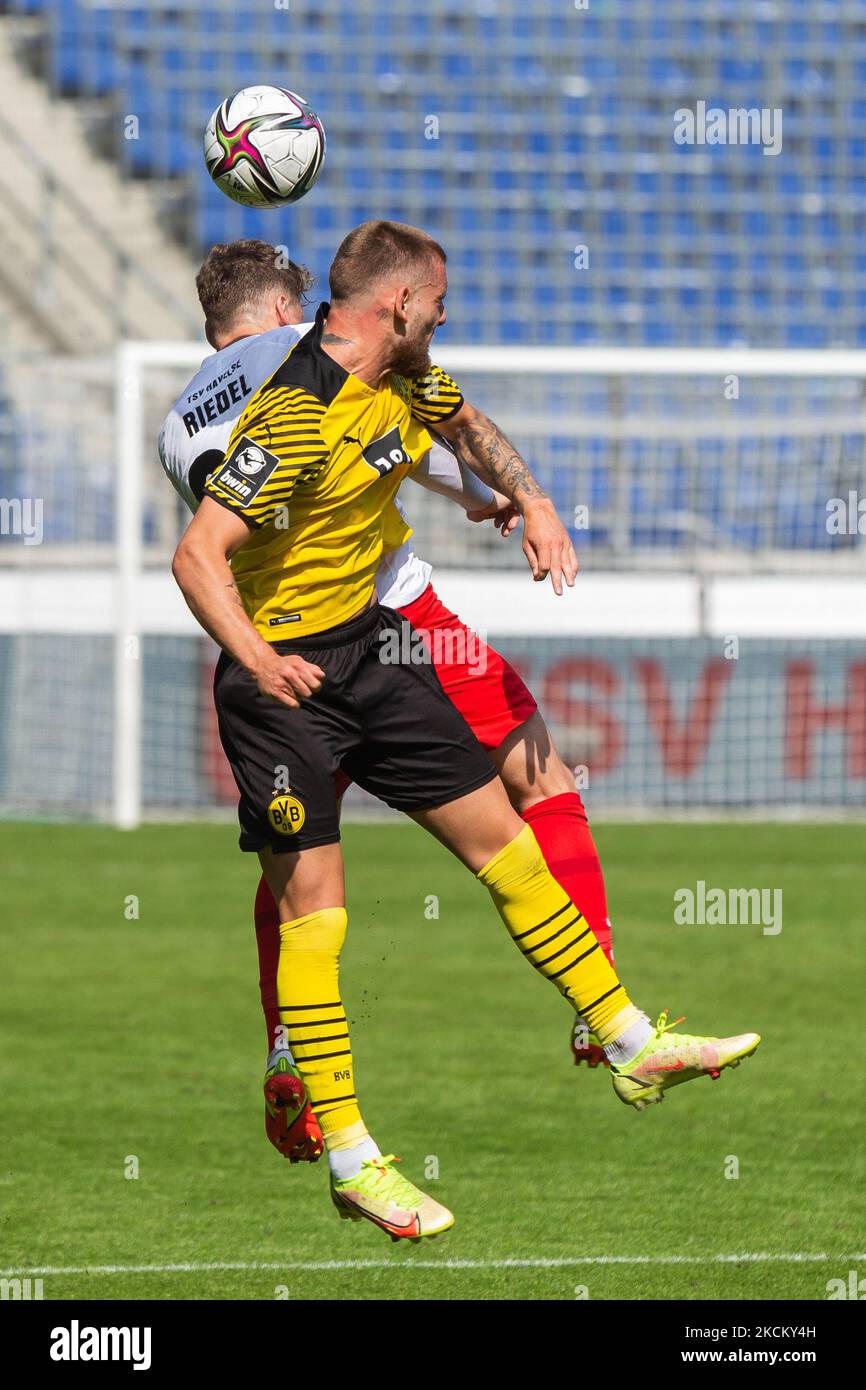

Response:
(204, 304), (463, 641)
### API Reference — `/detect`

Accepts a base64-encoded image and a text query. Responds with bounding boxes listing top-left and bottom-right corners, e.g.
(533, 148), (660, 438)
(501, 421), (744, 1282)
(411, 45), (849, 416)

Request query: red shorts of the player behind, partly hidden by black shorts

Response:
(399, 584), (538, 749)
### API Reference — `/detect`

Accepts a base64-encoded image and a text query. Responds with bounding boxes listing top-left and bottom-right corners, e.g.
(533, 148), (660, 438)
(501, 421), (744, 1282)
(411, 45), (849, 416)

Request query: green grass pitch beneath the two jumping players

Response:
(0, 824), (866, 1301)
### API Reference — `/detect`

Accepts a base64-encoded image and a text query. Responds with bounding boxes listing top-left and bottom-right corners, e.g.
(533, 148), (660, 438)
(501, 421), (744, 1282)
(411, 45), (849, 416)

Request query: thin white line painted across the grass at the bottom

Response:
(0, 1252), (866, 1279)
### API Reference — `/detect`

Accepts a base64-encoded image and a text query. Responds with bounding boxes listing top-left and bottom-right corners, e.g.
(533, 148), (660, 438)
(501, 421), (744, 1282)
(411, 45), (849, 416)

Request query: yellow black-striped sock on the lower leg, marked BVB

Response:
(277, 908), (367, 1143)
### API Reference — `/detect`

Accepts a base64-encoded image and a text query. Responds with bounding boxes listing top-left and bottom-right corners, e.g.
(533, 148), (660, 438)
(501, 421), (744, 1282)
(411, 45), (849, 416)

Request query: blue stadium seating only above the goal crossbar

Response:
(7, 0), (866, 346)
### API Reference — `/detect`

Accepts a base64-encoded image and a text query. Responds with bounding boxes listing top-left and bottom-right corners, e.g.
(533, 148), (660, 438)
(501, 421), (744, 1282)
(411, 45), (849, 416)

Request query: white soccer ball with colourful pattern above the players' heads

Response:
(204, 86), (325, 207)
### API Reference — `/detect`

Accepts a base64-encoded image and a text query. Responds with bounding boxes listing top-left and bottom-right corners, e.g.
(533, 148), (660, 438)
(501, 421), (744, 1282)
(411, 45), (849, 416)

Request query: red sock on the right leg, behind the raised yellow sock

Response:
(523, 791), (613, 965)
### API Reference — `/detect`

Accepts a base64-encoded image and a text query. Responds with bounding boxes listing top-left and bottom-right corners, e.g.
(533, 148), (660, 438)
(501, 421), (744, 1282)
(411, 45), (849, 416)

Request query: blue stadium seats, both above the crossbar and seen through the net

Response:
(6, 0), (866, 566)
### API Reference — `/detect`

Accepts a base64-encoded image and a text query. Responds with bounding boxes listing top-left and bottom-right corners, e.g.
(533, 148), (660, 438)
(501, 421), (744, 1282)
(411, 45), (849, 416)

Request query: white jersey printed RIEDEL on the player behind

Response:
(158, 324), (492, 607)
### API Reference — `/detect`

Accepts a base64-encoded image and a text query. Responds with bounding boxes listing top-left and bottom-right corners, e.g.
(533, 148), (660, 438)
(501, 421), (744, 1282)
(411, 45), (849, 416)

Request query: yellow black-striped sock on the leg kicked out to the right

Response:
(477, 826), (634, 1043)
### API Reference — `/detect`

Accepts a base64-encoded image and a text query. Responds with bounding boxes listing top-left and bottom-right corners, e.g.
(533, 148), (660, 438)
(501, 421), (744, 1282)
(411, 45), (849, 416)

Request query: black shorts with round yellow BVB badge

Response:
(214, 606), (496, 852)
